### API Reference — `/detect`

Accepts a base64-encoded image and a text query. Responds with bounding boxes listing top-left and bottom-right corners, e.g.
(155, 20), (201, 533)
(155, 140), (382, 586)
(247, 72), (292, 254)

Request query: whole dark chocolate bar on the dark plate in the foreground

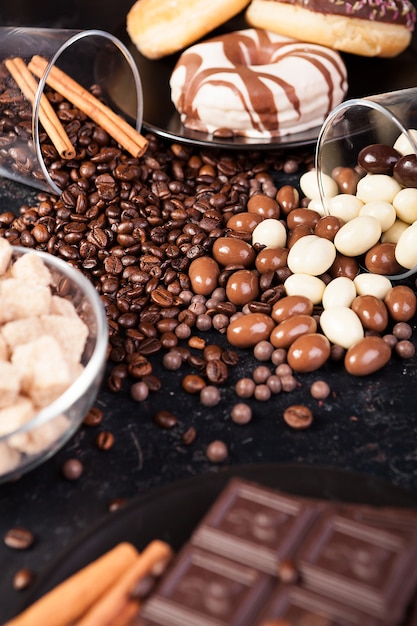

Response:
(135, 478), (417, 626)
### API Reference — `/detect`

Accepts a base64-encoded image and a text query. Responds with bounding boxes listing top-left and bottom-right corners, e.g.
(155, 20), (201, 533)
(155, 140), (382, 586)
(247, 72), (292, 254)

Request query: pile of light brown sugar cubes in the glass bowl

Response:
(0, 238), (88, 475)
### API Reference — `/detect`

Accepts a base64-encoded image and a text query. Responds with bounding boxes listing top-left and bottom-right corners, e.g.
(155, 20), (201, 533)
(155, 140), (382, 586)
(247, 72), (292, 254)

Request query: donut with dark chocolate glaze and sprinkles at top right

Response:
(245, 0), (416, 57)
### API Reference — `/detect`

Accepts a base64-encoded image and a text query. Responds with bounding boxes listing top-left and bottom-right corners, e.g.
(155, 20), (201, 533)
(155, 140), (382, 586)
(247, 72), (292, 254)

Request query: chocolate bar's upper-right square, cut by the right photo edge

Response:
(297, 512), (417, 623)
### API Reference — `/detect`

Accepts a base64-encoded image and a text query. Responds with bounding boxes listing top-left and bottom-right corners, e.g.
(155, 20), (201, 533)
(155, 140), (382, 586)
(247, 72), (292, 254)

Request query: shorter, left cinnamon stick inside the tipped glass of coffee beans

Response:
(5, 57), (76, 159)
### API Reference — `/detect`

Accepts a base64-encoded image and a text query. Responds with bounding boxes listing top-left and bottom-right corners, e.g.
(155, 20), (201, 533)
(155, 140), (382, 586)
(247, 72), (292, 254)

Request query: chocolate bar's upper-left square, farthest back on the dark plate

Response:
(191, 479), (322, 575)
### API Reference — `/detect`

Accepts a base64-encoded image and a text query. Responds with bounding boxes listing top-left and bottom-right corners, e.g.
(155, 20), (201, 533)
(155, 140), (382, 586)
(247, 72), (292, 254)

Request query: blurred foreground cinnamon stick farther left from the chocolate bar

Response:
(5, 542), (138, 626)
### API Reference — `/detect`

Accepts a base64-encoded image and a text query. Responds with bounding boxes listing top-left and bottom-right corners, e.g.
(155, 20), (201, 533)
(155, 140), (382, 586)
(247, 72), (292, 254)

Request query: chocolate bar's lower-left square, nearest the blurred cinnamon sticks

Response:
(139, 544), (275, 626)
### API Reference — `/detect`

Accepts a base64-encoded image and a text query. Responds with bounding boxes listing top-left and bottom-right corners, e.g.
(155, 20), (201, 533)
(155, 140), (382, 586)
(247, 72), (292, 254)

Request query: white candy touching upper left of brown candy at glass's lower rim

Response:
(334, 215), (382, 256)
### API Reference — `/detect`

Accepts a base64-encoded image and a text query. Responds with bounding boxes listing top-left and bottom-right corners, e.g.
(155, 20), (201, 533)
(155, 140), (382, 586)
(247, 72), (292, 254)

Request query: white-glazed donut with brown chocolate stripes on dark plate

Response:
(170, 28), (347, 138)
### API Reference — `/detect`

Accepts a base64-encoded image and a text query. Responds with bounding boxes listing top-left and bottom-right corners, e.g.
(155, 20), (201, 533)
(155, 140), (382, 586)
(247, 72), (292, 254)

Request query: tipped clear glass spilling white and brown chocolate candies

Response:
(315, 88), (417, 280)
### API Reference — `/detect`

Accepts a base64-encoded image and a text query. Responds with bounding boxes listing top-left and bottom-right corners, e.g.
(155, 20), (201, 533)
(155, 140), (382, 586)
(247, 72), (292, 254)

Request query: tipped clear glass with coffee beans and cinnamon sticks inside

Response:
(0, 27), (143, 194)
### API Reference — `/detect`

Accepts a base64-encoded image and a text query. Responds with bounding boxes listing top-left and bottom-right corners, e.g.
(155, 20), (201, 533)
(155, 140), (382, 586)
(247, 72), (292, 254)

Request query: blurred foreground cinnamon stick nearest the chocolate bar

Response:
(74, 540), (173, 626)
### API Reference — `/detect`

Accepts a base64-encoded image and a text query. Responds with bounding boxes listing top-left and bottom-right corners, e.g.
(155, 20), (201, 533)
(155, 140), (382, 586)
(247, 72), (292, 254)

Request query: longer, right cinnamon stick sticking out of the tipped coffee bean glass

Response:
(28, 55), (149, 157)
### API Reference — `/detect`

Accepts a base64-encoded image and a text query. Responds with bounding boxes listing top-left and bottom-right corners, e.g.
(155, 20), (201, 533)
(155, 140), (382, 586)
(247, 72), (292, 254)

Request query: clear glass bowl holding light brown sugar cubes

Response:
(0, 246), (108, 483)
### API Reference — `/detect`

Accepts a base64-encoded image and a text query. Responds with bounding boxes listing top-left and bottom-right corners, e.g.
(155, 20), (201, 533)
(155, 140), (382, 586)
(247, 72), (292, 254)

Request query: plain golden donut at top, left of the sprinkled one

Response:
(126, 0), (249, 59)
